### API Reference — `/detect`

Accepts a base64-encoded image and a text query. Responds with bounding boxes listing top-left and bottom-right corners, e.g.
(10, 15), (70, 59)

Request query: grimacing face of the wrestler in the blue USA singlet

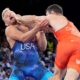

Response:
(3, 10), (16, 24)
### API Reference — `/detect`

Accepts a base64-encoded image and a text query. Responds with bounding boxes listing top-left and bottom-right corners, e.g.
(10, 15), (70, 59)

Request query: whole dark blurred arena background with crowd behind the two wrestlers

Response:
(0, 0), (80, 80)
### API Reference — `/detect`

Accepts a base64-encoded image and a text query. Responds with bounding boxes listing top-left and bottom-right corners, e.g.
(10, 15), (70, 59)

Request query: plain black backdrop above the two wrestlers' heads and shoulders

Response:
(0, 0), (80, 30)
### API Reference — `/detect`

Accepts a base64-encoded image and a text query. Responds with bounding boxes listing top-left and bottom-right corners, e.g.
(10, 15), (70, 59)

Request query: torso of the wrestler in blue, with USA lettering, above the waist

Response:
(12, 41), (39, 66)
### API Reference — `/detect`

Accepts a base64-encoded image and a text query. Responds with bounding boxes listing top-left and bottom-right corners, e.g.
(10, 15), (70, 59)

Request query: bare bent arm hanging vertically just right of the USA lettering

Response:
(37, 31), (47, 51)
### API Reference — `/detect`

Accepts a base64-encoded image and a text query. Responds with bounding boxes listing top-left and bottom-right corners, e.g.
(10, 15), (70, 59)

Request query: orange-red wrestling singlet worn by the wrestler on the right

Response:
(54, 22), (80, 73)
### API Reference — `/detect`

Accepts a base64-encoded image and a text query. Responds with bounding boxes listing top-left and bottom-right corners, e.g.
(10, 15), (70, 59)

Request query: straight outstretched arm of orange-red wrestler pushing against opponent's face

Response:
(16, 15), (46, 25)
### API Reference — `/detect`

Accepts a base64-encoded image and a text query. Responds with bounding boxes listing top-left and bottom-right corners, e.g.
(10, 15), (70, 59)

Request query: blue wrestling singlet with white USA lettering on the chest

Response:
(9, 41), (53, 80)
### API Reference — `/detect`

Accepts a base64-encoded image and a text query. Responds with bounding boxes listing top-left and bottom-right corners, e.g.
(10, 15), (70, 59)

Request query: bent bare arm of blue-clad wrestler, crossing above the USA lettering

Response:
(5, 26), (39, 42)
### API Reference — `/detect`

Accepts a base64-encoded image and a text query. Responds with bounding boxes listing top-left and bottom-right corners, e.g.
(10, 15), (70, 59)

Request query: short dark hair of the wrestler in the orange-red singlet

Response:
(46, 4), (63, 15)
